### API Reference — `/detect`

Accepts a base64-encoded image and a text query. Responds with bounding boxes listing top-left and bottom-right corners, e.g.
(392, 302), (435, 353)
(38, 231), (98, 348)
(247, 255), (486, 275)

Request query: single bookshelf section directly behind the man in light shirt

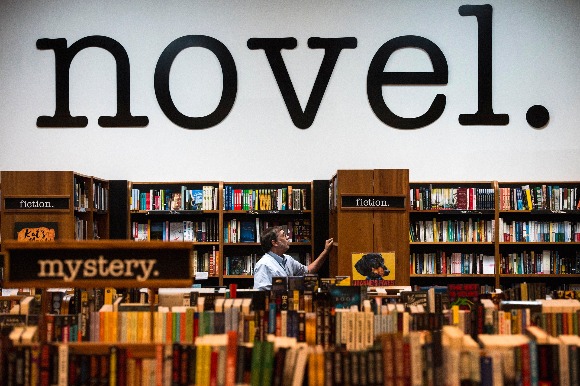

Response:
(222, 181), (315, 287)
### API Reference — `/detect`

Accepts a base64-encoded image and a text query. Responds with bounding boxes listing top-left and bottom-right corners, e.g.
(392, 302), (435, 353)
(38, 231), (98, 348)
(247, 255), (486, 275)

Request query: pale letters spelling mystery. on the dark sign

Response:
(38, 255), (159, 281)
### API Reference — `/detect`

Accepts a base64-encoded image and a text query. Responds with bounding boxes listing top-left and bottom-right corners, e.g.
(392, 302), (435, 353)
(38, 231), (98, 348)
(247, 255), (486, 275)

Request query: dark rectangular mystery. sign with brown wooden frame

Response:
(4, 240), (192, 288)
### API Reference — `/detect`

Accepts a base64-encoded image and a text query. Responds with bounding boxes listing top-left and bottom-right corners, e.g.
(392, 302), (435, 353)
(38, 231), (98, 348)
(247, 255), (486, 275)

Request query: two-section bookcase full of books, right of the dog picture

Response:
(409, 181), (580, 290)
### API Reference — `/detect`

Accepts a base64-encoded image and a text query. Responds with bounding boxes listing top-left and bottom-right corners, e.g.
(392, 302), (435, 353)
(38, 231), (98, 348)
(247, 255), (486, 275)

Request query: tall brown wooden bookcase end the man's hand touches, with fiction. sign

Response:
(329, 169), (409, 285)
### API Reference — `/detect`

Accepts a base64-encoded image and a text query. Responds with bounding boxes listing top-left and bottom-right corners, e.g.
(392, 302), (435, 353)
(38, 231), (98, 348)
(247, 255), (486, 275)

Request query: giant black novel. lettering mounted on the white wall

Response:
(31, 4), (550, 130)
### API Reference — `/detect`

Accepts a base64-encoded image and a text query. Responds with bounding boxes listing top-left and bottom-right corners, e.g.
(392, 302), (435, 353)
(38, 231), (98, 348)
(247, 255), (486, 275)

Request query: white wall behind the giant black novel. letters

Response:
(0, 0), (580, 181)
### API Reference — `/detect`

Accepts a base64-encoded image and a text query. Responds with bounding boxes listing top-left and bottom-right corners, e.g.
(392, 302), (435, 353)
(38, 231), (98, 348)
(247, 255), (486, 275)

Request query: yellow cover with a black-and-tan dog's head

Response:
(352, 252), (395, 286)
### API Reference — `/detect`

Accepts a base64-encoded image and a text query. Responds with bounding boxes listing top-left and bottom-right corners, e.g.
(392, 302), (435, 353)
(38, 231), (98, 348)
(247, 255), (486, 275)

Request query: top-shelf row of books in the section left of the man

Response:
(129, 185), (218, 211)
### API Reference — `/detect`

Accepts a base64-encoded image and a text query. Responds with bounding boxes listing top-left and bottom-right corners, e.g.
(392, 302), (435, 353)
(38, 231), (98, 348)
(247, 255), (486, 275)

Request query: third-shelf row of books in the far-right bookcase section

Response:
(500, 249), (580, 275)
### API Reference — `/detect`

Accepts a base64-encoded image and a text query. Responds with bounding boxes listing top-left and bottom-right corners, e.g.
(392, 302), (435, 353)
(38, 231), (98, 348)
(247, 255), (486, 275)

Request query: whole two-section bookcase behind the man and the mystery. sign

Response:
(127, 181), (314, 287)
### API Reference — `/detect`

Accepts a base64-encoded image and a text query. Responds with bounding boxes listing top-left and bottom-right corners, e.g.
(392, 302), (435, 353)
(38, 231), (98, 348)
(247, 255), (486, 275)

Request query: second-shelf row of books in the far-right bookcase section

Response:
(499, 217), (580, 243)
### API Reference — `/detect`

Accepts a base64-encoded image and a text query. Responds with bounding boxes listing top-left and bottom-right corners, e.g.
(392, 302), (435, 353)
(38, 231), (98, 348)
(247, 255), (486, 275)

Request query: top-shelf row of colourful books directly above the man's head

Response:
(223, 185), (309, 211)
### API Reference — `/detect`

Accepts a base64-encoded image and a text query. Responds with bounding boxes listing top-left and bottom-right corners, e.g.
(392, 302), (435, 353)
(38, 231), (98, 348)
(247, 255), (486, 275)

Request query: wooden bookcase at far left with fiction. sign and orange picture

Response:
(0, 171), (109, 250)
